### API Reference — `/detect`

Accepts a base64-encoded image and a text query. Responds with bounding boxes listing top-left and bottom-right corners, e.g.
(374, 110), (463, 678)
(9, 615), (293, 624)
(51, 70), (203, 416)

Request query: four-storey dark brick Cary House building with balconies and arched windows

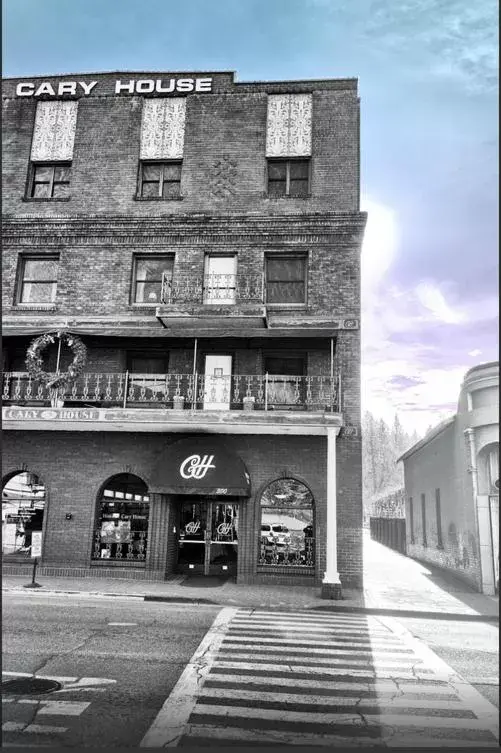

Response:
(3, 72), (366, 597)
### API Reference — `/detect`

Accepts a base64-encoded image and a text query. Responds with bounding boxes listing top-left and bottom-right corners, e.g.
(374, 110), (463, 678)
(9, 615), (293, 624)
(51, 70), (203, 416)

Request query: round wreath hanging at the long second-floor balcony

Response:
(26, 332), (87, 390)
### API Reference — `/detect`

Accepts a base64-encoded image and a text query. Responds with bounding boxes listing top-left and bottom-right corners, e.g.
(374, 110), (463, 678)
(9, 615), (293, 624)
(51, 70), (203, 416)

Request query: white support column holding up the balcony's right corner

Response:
(321, 429), (343, 599)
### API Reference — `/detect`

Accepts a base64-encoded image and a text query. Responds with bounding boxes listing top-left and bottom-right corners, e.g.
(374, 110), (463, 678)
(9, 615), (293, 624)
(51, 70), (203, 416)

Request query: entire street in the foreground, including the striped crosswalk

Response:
(2, 593), (498, 749)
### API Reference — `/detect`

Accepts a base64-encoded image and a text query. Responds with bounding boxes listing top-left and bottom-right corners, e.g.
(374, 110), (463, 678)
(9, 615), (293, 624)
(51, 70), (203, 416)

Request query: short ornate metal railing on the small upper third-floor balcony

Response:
(160, 272), (264, 305)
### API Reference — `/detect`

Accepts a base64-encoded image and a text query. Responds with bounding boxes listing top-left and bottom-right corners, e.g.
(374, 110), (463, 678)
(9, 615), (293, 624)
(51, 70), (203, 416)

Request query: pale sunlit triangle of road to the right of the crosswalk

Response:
(398, 617), (499, 708)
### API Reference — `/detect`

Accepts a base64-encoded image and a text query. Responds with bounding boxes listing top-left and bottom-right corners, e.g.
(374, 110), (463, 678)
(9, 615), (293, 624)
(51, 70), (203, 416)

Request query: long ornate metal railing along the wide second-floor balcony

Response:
(2, 372), (340, 412)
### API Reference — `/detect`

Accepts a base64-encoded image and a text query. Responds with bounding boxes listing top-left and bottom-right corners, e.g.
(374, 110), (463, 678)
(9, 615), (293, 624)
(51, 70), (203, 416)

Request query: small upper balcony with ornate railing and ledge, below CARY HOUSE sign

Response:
(156, 273), (266, 327)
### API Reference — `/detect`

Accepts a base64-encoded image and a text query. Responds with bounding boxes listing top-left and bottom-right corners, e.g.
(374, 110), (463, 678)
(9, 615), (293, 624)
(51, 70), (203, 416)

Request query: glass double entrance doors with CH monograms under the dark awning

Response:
(177, 499), (238, 575)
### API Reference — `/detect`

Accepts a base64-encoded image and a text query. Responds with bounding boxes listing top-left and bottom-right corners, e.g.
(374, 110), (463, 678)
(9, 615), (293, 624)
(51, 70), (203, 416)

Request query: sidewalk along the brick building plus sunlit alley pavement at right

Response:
(3, 534), (499, 622)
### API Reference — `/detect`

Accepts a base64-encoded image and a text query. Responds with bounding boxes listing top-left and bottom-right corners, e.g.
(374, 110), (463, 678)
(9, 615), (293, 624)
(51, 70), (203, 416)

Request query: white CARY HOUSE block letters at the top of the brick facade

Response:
(16, 78), (212, 97)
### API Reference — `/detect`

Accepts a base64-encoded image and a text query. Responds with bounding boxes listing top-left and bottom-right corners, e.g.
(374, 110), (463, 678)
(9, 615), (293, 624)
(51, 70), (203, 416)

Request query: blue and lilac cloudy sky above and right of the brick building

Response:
(2, 0), (498, 434)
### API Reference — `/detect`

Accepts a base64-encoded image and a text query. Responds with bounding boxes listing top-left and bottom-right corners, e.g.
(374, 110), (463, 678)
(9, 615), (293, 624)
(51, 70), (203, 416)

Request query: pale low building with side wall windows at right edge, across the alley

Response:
(400, 363), (499, 595)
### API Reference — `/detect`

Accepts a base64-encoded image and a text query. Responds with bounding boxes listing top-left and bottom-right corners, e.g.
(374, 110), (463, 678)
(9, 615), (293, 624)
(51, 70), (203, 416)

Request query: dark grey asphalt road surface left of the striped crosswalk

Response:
(2, 593), (220, 748)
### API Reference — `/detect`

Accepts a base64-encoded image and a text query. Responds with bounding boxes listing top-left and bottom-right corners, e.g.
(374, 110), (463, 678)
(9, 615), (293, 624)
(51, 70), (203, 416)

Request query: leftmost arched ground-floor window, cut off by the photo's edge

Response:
(2, 471), (45, 562)
